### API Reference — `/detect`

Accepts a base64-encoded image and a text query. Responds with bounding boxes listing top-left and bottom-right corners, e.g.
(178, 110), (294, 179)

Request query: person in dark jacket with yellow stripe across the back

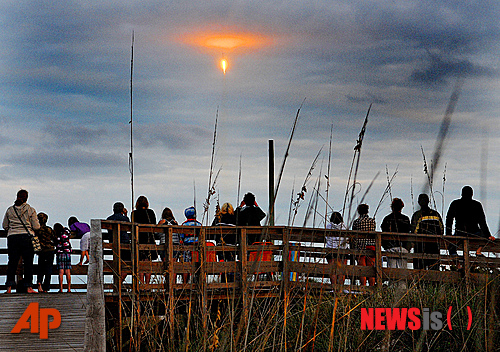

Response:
(411, 193), (444, 270)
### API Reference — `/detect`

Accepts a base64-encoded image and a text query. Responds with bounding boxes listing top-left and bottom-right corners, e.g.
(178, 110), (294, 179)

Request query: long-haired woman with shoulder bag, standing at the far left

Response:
(3, 189), (40, 293)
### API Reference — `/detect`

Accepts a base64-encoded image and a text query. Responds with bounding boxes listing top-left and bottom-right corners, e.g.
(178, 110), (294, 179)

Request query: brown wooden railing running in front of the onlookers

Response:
(0, 221), (500, 292)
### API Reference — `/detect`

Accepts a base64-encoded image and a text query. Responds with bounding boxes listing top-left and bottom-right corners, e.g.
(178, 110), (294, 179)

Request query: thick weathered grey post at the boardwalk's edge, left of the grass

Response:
(84, 219), (106, 352)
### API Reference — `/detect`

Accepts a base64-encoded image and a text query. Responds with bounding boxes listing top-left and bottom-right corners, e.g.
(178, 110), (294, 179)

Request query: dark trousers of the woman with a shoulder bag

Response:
(5, 233), (35, 287)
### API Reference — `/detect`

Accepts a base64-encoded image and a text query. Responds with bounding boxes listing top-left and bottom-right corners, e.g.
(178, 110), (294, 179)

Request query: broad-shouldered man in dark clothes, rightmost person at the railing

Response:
(446, 186), (495, 257)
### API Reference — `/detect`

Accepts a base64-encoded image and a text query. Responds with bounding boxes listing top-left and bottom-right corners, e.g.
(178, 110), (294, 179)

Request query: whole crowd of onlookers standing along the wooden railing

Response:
(3, 186), (495, 293)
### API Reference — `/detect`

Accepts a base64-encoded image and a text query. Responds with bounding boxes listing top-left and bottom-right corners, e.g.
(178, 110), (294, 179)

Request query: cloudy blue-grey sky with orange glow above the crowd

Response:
(0, 0), (500, 233)
